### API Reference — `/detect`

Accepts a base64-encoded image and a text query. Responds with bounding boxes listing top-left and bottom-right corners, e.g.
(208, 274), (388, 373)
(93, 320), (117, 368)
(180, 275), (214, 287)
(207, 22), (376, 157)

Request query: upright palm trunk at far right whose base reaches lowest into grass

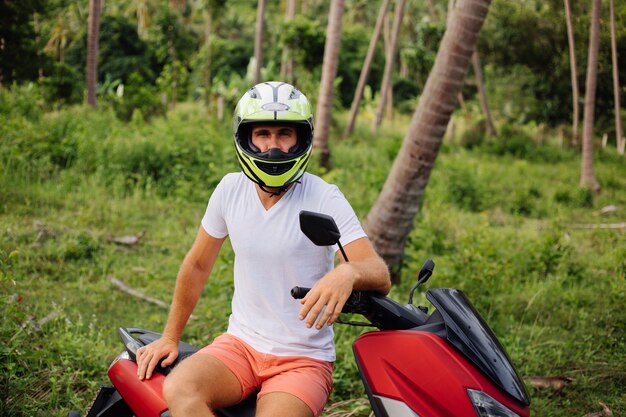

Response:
(580, 0), (602, 192)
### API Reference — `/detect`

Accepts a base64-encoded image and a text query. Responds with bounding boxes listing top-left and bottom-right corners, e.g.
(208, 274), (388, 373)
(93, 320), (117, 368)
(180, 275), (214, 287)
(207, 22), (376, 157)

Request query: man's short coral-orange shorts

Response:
(198, 334), (334, 416)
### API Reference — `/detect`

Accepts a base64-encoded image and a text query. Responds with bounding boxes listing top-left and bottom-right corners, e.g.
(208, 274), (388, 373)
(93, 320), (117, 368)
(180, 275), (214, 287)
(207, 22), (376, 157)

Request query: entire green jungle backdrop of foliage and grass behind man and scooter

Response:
(0, 0), (626, 417)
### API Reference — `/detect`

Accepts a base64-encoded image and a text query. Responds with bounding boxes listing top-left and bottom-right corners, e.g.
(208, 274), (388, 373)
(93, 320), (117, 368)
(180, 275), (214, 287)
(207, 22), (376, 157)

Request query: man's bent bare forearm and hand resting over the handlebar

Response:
(299, 237), (391, 329)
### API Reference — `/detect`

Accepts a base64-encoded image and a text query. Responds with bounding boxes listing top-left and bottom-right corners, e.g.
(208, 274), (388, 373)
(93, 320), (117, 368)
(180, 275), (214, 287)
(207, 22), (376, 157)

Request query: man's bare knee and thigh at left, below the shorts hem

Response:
(164, 354), (242, 408)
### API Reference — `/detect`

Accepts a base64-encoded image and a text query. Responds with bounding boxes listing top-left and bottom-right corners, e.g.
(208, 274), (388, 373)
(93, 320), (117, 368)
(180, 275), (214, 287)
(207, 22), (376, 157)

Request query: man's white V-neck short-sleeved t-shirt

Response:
(202, 172), (366, 361)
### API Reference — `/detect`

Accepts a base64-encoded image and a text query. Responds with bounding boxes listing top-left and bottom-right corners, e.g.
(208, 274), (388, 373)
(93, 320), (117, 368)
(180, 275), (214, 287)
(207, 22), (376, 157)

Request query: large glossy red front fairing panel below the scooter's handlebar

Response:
(354, 330), (530, 417)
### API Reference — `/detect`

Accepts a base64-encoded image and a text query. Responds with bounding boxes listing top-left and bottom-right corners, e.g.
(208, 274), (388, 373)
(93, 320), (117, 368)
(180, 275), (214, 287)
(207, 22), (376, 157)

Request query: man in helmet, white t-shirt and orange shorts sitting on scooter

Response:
(137, 82), (391, 417)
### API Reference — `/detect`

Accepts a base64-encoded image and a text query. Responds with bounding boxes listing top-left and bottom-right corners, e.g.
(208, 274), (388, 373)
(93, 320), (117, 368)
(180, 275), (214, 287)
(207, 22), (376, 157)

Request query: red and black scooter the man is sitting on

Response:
(69, 211), (530, 417)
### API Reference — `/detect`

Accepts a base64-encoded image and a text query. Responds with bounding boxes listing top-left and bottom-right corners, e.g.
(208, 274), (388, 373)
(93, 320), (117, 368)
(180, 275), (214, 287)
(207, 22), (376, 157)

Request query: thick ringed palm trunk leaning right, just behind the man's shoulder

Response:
(365, 0), (491, 282)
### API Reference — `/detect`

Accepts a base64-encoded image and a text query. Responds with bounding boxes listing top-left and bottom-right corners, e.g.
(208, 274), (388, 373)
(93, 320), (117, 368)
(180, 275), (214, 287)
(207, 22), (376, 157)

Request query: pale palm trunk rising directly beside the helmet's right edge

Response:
(313, 0), (344, 169)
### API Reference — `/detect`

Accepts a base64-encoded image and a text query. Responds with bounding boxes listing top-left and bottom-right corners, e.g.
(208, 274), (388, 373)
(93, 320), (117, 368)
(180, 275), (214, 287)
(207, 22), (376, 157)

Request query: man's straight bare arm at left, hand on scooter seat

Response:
(137, 226), (225, 379)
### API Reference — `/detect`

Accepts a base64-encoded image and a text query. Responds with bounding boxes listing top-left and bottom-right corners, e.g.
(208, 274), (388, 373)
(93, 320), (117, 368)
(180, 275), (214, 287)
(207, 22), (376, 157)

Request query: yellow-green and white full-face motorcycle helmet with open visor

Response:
(233, 81), (313, 190)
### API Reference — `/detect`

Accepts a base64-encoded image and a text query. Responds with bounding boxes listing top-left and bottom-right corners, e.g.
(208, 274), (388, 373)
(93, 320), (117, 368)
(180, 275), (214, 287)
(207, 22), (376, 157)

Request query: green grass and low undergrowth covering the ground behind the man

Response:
(0, 102), (626, 416)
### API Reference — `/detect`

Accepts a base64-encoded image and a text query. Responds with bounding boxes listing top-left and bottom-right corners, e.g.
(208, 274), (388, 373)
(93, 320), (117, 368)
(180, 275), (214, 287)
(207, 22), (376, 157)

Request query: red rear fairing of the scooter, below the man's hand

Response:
(108, 359), (167, 417)
